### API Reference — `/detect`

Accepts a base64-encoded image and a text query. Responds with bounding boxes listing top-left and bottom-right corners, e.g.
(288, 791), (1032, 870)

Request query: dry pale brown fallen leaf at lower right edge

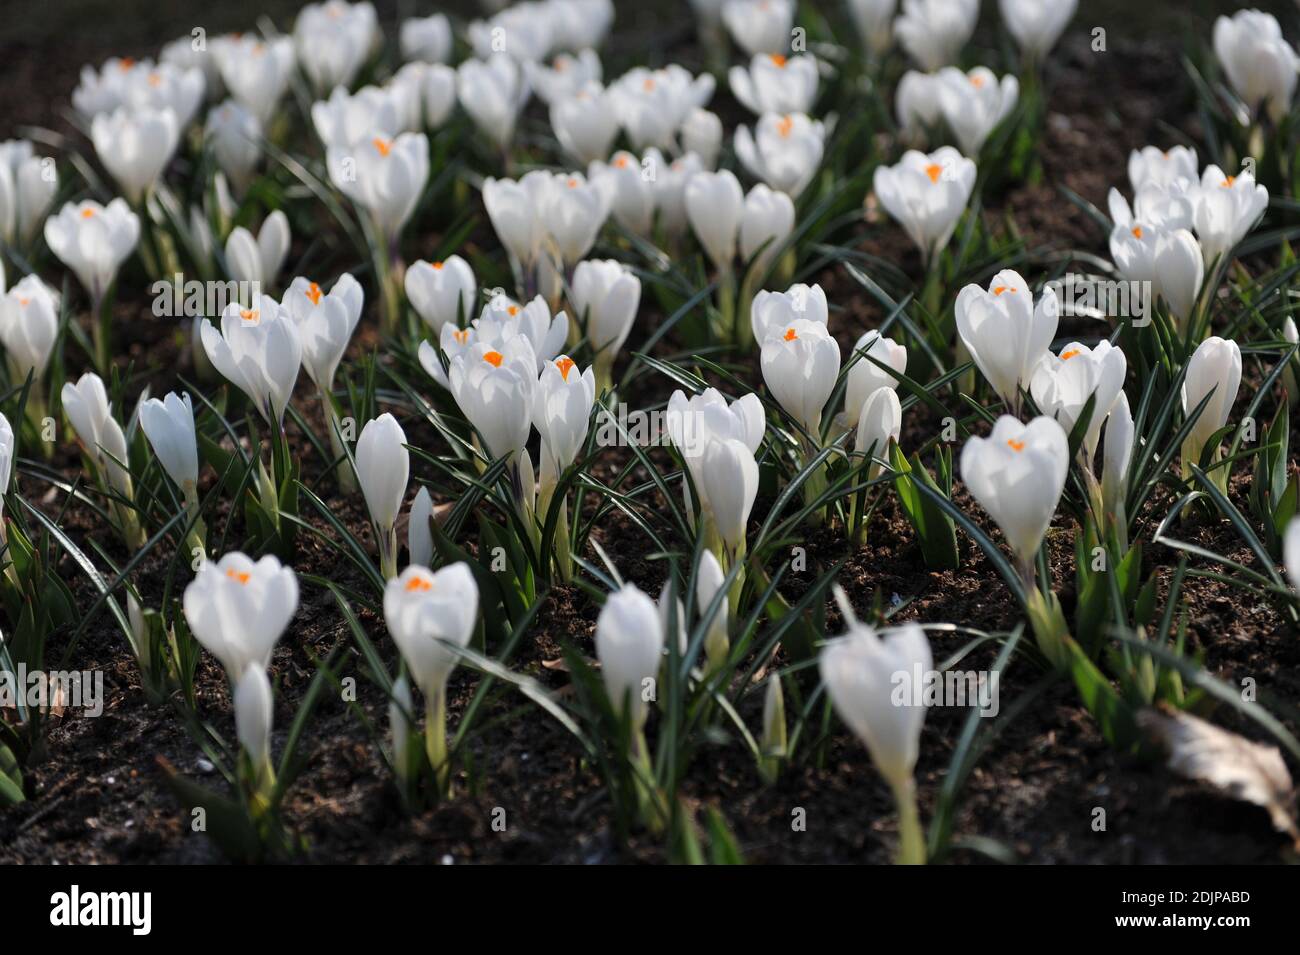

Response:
(1138, 707), (1300, 846)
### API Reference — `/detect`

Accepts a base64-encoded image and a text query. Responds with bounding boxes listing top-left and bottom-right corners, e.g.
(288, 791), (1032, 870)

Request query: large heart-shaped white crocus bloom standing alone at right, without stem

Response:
(961, 414), (1070, 566)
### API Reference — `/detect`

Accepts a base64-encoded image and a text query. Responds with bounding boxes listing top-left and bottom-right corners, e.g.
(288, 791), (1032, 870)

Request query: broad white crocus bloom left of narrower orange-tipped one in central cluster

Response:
(447, 335), (537, 460)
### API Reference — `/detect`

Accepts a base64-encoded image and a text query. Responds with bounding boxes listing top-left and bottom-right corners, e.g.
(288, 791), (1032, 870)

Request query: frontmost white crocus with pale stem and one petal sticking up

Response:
(818, 605), (933, 865)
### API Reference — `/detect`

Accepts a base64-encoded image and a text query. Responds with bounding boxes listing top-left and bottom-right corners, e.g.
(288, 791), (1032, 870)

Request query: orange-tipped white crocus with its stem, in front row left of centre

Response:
(384, 561), (478, 791)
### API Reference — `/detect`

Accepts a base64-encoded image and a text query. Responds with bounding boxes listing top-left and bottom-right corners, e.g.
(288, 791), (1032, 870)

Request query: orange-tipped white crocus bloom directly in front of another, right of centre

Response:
(762, 318), (840, 440)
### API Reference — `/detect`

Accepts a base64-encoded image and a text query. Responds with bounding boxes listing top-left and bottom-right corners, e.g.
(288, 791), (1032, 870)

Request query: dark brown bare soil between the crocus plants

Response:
(0, 3), (1300, 863)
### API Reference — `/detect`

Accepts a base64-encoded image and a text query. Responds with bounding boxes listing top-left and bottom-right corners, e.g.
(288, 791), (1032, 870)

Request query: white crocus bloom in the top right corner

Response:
(1214, 10), (1300, 122)
